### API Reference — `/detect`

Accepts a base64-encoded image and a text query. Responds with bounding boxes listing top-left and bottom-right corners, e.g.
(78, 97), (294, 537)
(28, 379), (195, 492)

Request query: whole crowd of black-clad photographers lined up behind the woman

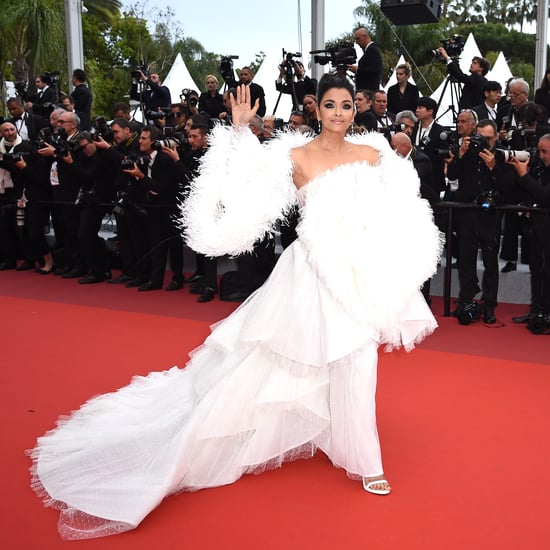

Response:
(0, 41), (550, 332)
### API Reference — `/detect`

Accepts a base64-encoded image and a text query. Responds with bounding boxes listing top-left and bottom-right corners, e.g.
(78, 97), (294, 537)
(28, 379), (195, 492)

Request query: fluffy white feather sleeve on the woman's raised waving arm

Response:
(180, 126), (307, 256)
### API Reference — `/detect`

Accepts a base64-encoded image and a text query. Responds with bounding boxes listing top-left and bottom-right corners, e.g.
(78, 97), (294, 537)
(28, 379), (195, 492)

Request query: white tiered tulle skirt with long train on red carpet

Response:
(30, 241), (436, 539)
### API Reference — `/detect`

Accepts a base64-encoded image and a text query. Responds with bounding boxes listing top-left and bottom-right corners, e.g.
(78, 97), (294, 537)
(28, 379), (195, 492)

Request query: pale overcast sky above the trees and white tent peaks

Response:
(123, 0), (361, 67)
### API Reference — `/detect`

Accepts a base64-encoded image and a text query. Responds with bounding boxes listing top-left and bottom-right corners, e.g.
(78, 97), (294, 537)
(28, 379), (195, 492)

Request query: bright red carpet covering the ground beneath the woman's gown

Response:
(0, 272), (550, 550)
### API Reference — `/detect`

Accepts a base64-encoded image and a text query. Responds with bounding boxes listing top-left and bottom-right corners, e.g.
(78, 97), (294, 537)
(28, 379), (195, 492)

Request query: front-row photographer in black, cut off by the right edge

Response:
(510, 134), (550, 332)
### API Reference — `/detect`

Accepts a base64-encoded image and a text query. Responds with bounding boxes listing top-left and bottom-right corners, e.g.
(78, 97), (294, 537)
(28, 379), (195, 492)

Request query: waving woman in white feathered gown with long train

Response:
(30, 75), (441, 539)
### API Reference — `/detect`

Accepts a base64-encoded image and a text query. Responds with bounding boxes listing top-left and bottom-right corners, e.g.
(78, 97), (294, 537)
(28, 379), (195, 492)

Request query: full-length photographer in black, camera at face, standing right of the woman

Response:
(448, 117), (516, 324)
